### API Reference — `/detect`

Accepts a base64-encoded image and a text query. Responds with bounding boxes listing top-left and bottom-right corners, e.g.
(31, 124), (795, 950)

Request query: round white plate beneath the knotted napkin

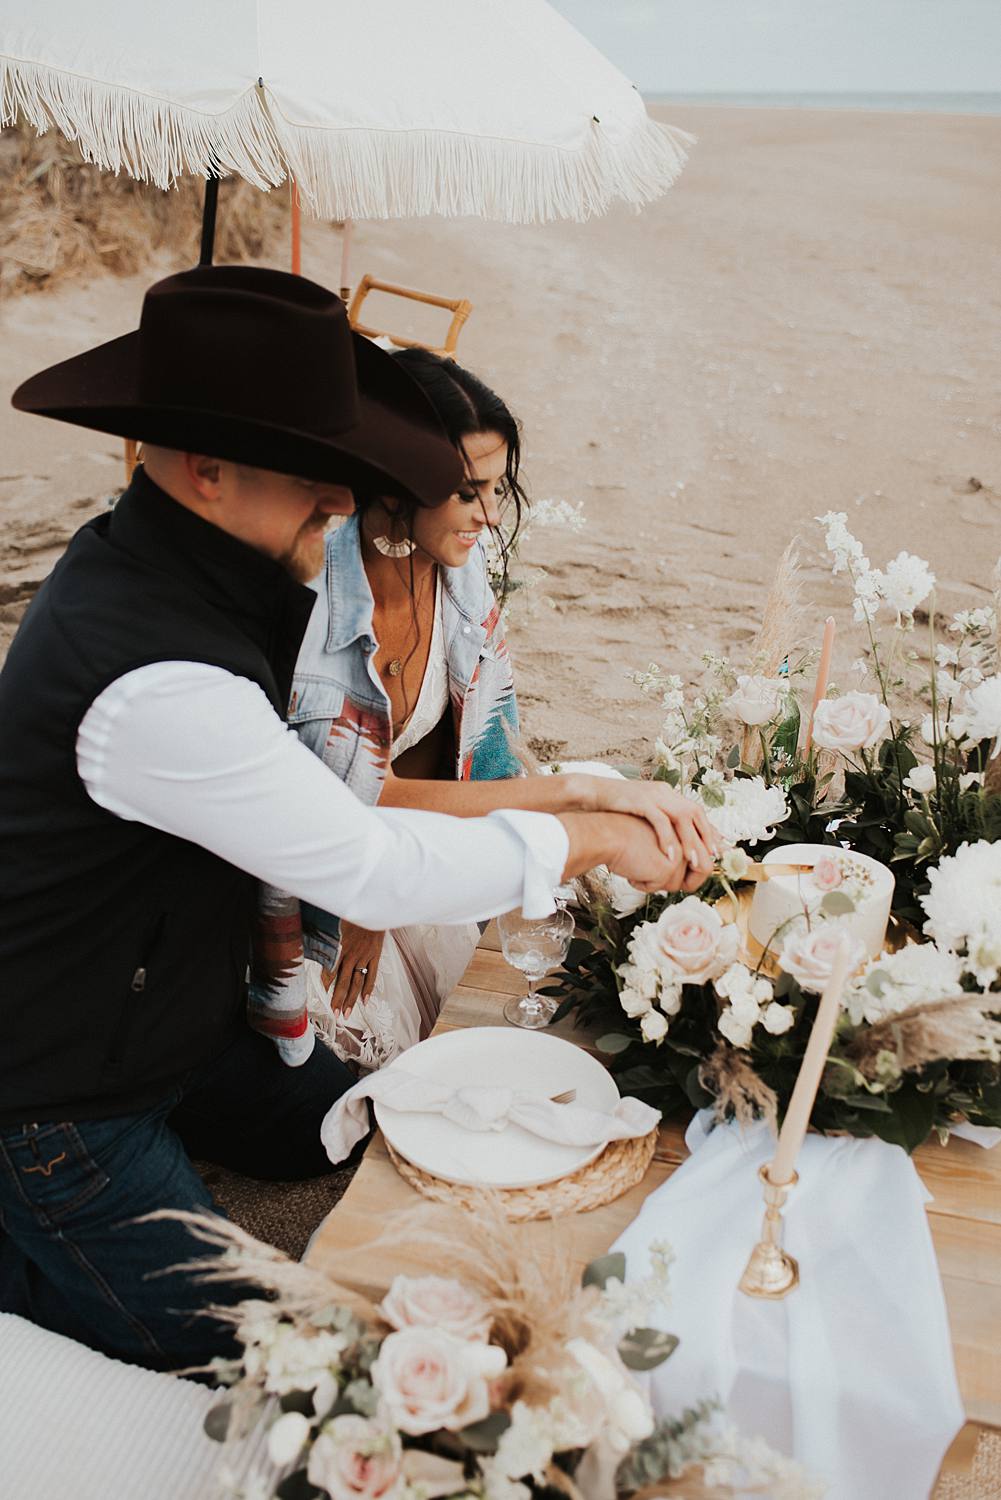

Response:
(375, 1026), (618, 1188)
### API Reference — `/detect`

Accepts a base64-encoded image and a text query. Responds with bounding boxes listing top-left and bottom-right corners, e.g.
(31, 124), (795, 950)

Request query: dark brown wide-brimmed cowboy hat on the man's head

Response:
(12, 266), (462, 506)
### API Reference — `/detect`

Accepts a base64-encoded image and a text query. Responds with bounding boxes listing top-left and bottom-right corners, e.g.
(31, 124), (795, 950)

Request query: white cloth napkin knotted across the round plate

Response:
(320, 1064), (660, 1161)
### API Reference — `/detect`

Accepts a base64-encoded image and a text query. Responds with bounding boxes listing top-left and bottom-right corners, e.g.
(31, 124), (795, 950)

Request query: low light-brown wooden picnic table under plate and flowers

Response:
(311, 930), (1001, 1469)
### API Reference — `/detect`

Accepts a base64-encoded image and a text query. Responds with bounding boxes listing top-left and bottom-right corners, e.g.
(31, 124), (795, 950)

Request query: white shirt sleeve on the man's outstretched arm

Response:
(77, 662), (569, 932)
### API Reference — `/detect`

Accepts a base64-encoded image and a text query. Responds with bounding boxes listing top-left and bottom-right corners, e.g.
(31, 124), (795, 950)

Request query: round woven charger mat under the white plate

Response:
(386, 1128), (657, 1223)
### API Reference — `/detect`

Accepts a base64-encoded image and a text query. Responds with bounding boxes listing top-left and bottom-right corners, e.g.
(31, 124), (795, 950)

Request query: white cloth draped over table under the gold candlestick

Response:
(614, 1118), (963, 1500)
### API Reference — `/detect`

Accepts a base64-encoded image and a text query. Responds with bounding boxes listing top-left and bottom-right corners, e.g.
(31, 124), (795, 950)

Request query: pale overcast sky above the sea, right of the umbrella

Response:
(552, 0), (1001, 93)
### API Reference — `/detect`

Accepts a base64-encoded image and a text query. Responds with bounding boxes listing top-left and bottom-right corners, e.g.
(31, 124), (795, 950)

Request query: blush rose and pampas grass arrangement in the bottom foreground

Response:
(189, 1200), (813, 1500)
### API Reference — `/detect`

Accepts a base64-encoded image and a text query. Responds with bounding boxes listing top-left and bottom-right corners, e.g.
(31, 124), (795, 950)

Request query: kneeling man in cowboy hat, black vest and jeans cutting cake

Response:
(0, 267), (704, 1368)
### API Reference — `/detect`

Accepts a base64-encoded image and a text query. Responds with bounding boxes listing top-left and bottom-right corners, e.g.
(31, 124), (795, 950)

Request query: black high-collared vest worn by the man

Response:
(0, 470), (315, 1124)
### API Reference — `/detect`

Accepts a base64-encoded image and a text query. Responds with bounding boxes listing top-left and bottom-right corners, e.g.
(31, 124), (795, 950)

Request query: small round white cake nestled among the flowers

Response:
(747, 845), (894, 959)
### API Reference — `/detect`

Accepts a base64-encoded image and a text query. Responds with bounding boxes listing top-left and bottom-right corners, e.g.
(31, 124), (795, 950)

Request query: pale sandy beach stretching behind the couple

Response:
(0, 105), (1001, 761)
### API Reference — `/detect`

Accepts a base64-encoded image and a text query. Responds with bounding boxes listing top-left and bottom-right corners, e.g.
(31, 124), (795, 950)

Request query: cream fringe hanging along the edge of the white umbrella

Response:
(0, 57), (692, 224)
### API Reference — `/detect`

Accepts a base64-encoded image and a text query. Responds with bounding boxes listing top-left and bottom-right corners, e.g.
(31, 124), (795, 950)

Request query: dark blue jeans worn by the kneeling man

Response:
(0, 1029), (354, 1370)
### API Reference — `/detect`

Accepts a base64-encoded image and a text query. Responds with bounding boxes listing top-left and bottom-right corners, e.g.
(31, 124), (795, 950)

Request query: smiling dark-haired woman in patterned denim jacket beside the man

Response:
(251, 350), (714, 1068)
